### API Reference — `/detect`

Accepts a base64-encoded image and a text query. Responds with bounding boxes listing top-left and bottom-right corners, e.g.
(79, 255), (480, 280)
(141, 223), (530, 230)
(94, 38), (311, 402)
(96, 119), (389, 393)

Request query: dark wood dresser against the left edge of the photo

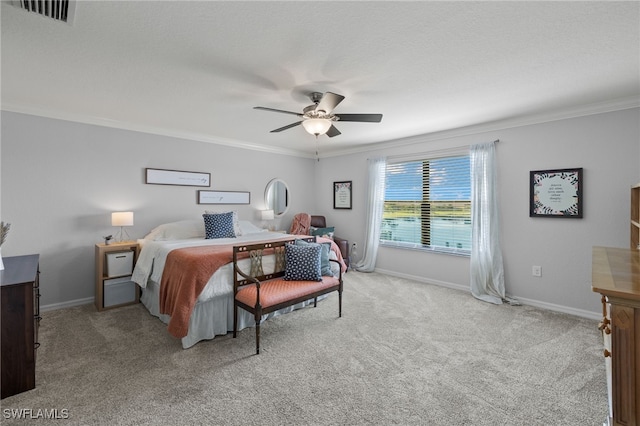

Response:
(0, 254), (40, 398)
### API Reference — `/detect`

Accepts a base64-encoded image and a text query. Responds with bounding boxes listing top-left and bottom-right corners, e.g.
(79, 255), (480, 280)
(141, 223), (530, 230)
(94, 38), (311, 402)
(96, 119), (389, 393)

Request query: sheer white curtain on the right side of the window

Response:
(471, 142), (514, 304)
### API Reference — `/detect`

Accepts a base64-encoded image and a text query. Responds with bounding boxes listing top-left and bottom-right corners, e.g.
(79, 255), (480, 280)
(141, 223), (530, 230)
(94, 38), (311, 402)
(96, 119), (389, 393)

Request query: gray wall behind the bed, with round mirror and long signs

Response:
(1, 111), (315, 308)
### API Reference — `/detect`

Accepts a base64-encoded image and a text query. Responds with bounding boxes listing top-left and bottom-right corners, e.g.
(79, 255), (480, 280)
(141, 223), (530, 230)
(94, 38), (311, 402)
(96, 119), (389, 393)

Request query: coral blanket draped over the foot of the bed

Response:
(160, 244), (238, 338)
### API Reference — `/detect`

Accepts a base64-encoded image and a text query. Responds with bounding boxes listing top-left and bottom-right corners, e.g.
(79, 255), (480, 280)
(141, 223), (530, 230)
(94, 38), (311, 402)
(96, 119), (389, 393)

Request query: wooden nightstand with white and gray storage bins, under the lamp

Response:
(95, 241), (140, 311)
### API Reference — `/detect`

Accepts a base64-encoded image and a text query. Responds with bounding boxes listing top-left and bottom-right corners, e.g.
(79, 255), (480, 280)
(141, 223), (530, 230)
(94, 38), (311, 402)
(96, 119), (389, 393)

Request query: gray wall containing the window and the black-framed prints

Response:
(316, 108), (640, 318)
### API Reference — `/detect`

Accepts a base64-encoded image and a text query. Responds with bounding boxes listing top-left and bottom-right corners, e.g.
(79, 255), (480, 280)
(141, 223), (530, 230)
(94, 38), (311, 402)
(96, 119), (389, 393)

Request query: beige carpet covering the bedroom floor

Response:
(1, 272), (607, 426)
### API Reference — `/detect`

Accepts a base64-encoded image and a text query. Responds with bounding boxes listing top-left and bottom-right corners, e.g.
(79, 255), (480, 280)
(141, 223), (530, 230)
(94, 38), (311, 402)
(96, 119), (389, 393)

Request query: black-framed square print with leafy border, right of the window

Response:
(529, 168), (583, 219)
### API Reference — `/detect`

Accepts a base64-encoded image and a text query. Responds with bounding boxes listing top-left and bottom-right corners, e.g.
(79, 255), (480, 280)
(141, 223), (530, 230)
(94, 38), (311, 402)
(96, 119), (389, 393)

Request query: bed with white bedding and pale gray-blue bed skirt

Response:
(132, 216), (346, 349)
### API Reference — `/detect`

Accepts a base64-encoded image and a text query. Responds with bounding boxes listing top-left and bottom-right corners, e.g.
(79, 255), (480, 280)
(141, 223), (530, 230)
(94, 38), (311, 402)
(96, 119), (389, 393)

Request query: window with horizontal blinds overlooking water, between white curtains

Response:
(380, 154), (471, 255)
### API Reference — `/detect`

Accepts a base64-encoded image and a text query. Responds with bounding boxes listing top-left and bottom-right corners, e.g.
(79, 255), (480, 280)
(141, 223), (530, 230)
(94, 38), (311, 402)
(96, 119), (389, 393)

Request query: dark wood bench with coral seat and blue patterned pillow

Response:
(233, 237), (342, 354)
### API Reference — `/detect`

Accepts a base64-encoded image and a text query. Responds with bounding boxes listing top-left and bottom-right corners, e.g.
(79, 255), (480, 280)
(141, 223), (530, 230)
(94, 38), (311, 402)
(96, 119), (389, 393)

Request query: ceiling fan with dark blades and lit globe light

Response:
(253, 92), (382, 138)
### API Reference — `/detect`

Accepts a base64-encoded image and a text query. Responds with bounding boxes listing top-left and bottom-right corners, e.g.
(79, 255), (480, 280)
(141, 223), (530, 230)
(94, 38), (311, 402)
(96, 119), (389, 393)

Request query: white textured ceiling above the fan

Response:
(1, 1), (640, 156)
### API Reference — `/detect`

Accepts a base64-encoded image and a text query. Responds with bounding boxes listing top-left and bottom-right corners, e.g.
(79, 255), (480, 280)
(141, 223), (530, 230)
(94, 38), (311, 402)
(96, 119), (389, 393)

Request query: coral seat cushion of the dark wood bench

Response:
(236, 277), (340, 308)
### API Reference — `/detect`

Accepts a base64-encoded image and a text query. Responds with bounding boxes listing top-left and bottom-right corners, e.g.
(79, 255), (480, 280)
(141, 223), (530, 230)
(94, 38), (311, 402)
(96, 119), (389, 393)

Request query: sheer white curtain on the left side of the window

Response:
(355, 157), (387, 272)
